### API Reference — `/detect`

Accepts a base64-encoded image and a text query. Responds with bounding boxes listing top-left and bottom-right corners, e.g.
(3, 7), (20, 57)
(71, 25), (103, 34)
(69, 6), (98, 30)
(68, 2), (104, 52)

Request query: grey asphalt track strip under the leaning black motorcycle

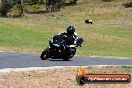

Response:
(0, 52), (132, 69)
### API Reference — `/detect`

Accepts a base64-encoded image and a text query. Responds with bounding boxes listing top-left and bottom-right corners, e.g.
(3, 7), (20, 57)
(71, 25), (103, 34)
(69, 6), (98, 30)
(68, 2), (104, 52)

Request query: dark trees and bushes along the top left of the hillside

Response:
(0, 0), (77, 17)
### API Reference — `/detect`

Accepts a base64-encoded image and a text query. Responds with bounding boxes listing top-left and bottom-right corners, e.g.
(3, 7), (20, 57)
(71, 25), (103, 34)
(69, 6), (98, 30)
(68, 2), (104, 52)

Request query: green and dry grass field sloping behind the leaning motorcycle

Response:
(0, 0), (132, 57)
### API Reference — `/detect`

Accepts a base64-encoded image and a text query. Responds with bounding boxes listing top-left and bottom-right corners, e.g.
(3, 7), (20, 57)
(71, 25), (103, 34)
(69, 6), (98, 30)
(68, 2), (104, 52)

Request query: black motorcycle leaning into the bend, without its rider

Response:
(40, 35), (83, 61)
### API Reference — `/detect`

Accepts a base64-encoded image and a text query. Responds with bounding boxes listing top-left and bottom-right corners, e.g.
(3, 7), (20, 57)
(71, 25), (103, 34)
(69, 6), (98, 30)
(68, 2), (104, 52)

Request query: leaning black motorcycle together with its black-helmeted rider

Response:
(40, 26), (83, 60)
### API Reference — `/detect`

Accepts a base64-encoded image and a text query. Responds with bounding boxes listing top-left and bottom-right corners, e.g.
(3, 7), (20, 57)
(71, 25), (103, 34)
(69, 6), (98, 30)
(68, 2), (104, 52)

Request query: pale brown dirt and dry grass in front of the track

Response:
(0, 66), (132, 88)
